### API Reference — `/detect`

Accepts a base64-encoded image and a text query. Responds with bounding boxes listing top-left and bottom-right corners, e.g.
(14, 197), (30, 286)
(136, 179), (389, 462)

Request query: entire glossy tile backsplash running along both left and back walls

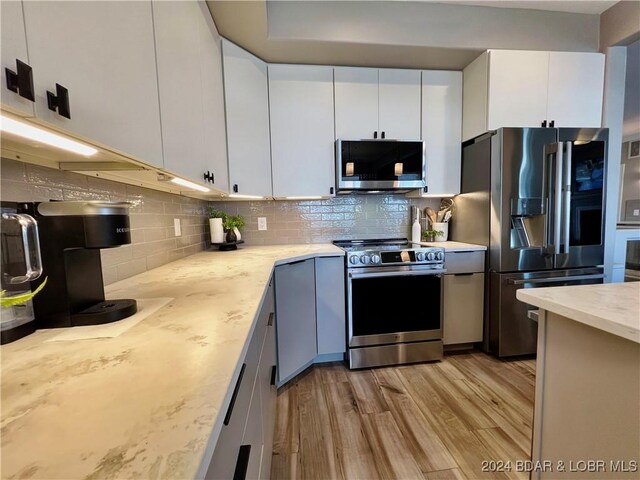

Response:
(0, 158), (439, 284)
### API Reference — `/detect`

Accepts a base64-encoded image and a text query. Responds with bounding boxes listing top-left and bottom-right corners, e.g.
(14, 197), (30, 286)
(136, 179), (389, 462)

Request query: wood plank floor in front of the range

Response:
(271, 352), (535, 480)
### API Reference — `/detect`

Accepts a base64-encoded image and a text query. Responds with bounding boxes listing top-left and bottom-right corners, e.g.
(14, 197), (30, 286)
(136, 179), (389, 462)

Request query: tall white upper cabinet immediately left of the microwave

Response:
(269, 65), (335, 198)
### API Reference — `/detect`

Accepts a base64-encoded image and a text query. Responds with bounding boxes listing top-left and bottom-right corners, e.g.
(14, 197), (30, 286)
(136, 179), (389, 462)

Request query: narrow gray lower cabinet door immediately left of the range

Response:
(316, 257), (346, 355)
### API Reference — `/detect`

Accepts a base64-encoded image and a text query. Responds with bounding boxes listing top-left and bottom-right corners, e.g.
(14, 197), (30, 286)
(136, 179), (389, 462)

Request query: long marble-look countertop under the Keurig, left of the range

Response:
(0, 244), (344, 479)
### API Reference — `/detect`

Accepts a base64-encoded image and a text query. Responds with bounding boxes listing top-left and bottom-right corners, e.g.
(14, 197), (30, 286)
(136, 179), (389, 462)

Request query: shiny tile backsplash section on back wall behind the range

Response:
(212, 195), (440, 245)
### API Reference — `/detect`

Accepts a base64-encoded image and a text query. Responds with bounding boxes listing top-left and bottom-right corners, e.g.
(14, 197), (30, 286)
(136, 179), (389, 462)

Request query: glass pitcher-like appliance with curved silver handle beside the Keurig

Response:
(0, 202), (42, 345)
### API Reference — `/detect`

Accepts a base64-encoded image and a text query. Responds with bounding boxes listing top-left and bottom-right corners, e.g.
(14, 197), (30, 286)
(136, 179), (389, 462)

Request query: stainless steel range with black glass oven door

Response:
(334, 238), (445, 368)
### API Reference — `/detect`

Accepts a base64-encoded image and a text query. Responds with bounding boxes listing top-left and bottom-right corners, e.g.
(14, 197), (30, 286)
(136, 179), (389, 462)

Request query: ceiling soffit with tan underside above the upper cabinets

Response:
(207, 0), (616, 70)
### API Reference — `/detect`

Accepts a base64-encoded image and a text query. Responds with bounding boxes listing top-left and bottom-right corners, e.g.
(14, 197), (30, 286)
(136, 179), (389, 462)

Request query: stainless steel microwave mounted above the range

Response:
(336, 140), (426, 194)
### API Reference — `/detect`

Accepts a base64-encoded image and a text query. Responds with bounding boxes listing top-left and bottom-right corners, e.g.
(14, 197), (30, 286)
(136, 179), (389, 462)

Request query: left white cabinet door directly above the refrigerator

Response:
(482, 50), (549, 133)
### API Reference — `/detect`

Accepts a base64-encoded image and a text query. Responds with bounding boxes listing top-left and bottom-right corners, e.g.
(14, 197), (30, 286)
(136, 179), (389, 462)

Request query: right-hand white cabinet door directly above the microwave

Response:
(379, 69), (420, 140)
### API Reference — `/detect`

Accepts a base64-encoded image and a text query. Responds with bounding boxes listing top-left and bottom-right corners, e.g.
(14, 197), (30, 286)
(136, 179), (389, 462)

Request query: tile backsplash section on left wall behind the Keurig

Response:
(0, 158), (209, 284)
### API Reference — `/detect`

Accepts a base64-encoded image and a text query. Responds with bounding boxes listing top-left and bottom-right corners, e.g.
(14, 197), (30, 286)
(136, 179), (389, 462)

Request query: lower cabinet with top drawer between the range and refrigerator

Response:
(443, 251), (484, 345)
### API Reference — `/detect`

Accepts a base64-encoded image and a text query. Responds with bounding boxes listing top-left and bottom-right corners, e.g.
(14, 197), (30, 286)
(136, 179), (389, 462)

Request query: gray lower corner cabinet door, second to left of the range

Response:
(276, 259), (317, 384)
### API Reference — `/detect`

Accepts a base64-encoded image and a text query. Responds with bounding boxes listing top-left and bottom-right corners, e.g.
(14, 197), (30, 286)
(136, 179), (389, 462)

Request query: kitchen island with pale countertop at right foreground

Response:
(517, 283), (640, 479)
